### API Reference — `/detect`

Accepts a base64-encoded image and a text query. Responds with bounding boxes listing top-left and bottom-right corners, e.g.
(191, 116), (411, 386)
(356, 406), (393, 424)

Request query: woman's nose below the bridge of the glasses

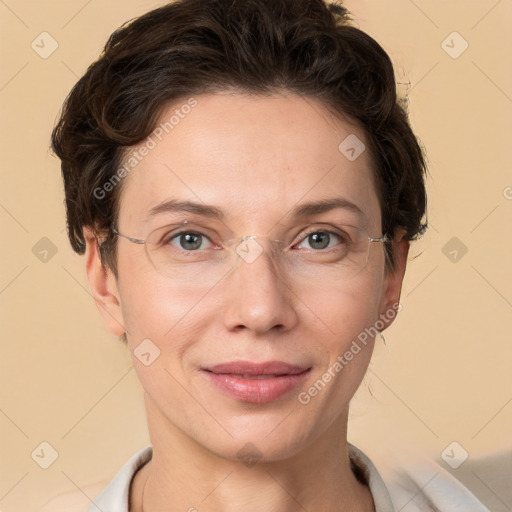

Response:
(223, 237), (297, 334)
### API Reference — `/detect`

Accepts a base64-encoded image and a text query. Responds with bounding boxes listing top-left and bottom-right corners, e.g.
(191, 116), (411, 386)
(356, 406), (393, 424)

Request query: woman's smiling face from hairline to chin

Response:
(88, 94), (406, 460)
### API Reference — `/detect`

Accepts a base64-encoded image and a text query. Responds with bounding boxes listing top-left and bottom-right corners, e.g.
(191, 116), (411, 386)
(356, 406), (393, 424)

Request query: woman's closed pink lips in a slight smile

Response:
(203, 361), (311, 404)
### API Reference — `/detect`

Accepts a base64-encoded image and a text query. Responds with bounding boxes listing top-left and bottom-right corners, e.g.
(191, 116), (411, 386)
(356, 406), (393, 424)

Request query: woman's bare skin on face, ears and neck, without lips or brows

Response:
(85, 93), (408, 512)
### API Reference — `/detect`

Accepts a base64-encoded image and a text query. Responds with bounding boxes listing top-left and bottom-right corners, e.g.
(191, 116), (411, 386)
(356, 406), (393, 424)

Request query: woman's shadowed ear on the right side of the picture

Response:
(379, 230), (409, 328)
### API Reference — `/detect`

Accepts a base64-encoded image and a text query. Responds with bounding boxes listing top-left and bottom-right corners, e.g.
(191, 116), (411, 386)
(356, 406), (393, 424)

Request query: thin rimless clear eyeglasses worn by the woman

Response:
(112, 221), (389, 282)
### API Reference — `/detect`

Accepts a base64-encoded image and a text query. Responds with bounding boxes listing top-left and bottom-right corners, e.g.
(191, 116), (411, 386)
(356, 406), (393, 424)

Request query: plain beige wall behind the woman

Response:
(0, 0), (512, 512)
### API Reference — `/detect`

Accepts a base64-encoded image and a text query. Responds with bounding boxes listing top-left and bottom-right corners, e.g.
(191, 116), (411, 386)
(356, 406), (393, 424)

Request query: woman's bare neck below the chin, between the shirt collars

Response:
(130, 403), (375, 512)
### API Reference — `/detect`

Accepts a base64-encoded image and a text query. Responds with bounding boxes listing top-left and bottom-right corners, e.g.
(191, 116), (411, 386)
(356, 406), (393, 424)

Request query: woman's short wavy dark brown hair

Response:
(52, 0), (426, 274)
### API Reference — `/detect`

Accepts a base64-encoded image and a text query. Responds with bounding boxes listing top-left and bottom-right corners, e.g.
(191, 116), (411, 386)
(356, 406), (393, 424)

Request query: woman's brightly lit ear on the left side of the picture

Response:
(84, 227), (126, 336)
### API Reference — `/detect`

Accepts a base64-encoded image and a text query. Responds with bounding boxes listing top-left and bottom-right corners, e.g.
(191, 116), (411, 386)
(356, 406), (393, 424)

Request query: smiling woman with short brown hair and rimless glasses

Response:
(53, 0), (486, 512)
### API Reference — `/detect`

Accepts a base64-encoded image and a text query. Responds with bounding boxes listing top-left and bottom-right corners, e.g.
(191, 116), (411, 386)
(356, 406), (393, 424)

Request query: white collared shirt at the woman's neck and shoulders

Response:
(84, 443), (490, 512)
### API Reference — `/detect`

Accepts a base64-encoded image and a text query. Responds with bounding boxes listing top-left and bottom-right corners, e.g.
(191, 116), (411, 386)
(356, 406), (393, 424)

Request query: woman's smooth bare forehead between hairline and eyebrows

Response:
(119, 93), (380, 230)
